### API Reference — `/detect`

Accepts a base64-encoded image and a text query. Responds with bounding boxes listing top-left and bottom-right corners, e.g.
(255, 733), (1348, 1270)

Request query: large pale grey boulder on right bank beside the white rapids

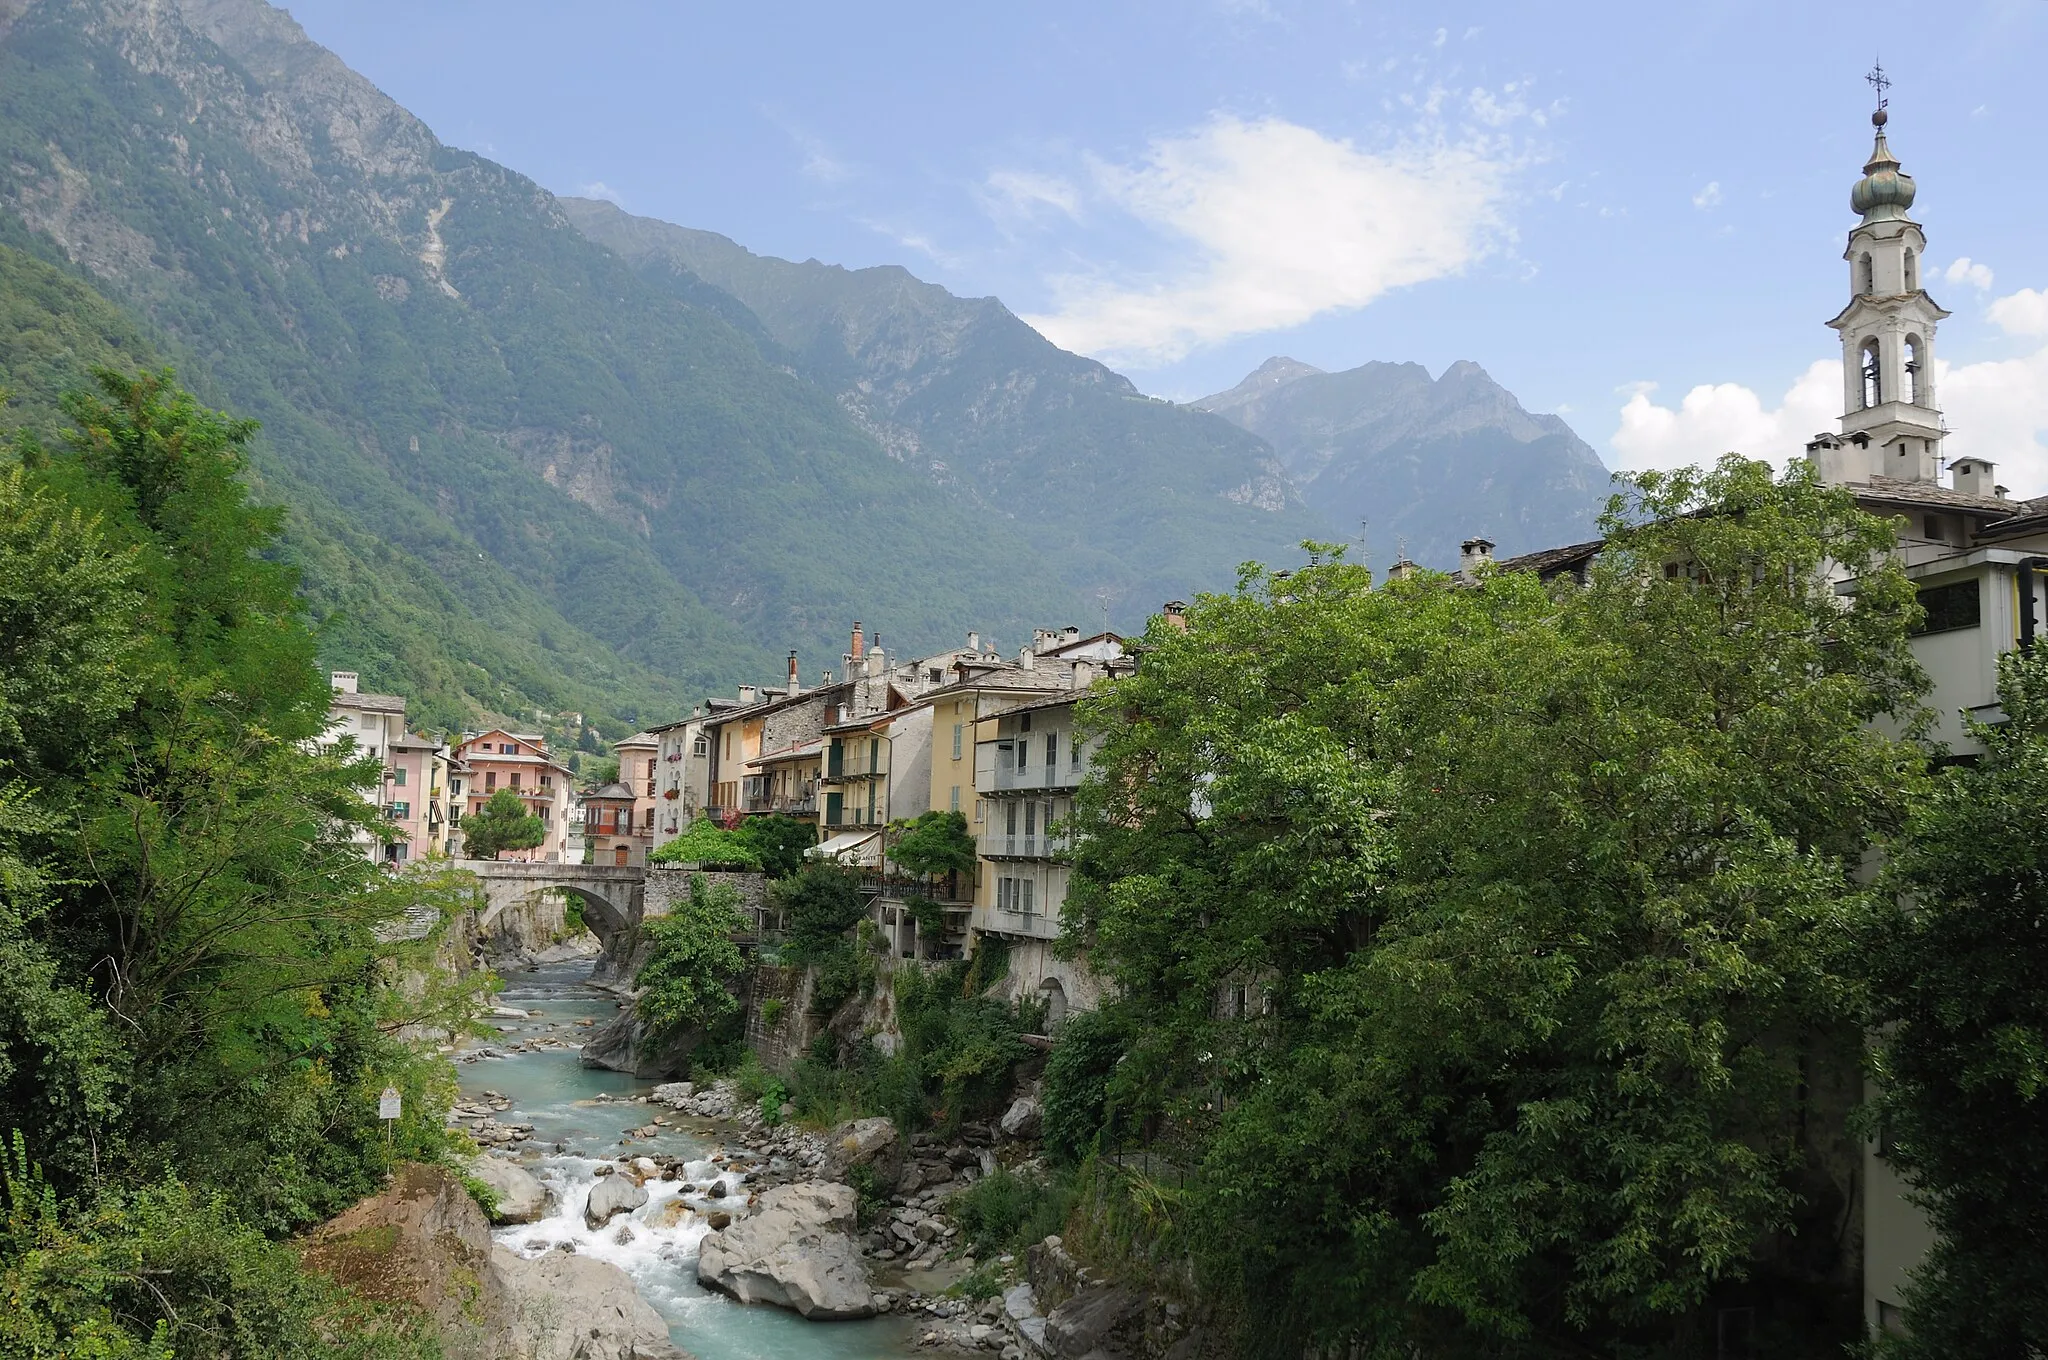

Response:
(696, 1180), (874, 1321)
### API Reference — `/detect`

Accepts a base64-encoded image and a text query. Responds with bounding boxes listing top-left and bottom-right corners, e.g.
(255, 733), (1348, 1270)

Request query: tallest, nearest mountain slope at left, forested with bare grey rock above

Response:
(0, 0), (1067, 717)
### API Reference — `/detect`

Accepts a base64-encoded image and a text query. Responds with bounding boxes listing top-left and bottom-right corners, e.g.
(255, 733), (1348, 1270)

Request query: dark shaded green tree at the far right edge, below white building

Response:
(1866, 653), (2048, 1356)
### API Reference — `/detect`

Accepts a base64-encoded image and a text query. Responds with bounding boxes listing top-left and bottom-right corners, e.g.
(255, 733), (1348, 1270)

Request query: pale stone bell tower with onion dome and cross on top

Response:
(1829, 66), (1948, 481)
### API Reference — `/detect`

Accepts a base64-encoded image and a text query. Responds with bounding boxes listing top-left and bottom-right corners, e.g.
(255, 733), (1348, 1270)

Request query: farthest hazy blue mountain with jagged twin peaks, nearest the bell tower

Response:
(1192, 358), (1608, 567)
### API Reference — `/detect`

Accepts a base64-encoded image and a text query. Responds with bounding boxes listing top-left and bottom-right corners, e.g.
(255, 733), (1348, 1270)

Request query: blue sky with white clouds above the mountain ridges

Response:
(291, 0), (2048, 494)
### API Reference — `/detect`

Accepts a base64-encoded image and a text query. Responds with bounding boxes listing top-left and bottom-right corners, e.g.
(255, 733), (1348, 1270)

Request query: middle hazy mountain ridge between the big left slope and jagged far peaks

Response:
(559, 199), (1317, 623)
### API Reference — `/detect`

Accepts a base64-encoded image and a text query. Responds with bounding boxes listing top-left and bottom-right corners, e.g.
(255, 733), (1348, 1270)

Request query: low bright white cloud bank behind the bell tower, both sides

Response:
(1612, 291), (2048, 496)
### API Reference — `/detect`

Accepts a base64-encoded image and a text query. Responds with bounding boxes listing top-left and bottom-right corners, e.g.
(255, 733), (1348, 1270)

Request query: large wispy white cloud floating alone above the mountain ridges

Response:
(1026, 115), (1513, 367)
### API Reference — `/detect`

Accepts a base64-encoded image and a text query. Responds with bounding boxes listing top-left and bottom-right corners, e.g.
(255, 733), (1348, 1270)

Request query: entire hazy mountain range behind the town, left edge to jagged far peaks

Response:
(0, 0), (1604, 729)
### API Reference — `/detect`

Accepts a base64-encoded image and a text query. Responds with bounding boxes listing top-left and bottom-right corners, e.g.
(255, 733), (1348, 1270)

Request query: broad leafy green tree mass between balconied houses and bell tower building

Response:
(1063, 459), (1921, 1356)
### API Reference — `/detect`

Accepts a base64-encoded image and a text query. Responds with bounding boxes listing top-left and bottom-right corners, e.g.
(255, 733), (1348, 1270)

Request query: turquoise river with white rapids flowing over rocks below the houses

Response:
(457, 963), (911, 1360)
